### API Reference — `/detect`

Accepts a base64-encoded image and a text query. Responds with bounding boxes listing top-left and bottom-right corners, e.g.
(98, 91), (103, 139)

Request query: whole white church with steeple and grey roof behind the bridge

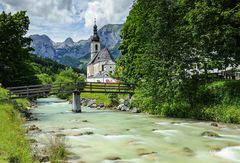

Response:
(87, 21), (117, 83)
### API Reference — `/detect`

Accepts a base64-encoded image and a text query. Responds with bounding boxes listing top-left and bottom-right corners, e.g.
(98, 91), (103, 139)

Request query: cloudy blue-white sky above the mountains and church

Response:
(0, 0), (133, 42)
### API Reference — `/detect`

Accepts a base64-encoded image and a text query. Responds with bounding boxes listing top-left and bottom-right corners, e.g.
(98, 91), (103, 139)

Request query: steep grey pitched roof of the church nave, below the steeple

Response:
(89, 48), (115, 65)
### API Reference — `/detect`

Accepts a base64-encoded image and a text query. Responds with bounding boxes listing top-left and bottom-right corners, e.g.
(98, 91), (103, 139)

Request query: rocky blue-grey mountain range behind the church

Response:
(29, 24), (123, 67)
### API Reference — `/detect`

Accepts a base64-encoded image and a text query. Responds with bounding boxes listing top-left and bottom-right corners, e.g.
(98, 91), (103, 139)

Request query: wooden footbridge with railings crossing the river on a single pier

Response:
(7, 82), (134, 112)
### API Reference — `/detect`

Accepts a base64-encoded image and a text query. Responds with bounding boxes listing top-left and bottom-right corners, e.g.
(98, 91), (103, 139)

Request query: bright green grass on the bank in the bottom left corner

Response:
(0, 102), (32, 163)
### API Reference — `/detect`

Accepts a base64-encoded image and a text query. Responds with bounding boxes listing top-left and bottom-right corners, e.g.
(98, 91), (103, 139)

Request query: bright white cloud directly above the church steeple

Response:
(84, 0), (133, 28)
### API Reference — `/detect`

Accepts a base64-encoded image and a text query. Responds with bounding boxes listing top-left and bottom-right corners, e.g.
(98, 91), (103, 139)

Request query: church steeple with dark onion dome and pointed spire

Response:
(91, 19), (101, 59)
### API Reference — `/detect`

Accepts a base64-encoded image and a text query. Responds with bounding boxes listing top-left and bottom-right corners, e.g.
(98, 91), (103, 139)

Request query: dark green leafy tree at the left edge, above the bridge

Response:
(0, 11), (39, 86)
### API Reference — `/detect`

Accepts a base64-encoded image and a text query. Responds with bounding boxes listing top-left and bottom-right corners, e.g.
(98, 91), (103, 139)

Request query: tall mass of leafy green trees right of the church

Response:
(116, 0), (240, 117)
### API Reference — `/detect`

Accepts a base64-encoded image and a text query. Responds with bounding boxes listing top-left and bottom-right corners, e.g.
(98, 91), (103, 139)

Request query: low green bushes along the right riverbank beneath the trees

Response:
(132, 81), (240, 123)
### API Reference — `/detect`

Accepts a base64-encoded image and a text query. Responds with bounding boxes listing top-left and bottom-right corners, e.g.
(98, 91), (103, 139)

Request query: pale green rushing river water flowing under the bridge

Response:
(27, 98), (240, 163)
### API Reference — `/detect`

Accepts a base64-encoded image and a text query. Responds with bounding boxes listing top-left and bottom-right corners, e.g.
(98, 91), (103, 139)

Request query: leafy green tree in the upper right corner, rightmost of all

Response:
(184, 0), (240, 72)
